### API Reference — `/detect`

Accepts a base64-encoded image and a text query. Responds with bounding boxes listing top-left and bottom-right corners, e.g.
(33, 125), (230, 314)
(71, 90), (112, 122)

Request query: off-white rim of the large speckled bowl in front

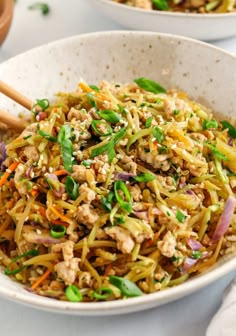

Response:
(0, 30), (236, 316)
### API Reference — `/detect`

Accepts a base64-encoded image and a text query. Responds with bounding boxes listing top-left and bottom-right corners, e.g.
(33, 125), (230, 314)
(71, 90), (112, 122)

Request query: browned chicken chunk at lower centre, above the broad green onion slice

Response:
(105, 226), (135, 253)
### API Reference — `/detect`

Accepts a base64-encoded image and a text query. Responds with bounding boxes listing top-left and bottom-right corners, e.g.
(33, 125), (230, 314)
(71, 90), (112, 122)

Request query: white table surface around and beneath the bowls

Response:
(0, 0), (236, 336)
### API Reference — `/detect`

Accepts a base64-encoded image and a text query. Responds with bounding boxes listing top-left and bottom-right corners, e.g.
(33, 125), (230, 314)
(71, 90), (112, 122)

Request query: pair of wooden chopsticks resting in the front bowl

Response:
(0, 81), (33, 131)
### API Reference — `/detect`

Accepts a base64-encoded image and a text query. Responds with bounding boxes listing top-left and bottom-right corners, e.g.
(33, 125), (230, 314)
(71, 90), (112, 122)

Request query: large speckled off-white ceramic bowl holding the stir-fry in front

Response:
(0, 31), (236, 315)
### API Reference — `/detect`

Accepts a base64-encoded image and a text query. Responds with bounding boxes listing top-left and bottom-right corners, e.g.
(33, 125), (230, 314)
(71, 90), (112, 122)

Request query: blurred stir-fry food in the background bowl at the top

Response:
(113, 0), (236, 13)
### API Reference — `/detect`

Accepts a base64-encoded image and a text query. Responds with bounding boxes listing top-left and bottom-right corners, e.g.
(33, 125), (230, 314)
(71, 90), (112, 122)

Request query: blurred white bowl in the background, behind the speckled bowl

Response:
(89, 0), (236, 41)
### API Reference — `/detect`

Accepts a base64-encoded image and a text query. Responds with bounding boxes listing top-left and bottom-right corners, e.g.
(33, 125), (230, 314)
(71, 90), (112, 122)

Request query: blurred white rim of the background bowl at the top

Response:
(90, 0), (236, 20)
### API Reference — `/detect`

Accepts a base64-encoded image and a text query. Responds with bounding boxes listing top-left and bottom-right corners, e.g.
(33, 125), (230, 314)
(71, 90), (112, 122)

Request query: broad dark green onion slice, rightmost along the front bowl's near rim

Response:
(109, 275), (143, 297)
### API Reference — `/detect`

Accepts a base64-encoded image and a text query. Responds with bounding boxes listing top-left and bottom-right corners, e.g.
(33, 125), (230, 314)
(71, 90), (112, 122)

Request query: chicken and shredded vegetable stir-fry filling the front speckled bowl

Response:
(0, 78), (236, 302)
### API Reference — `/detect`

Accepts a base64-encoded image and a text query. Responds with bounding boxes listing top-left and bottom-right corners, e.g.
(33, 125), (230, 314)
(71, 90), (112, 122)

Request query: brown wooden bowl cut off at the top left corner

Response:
(0, 0), (14, 44)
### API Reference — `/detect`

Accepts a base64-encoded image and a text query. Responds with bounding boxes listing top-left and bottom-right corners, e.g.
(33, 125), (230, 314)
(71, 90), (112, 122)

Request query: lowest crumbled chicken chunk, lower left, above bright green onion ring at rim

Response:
(54, 258), (80, 286)
